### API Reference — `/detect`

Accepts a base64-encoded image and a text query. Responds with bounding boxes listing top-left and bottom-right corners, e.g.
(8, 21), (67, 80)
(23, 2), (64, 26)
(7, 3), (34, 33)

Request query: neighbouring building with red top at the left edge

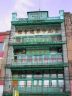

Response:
(0, 32), (9, 96)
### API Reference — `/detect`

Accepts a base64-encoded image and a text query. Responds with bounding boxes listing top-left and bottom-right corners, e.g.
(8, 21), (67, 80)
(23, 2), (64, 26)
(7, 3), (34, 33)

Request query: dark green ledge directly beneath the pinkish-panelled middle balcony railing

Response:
(6, 63), (68, 70)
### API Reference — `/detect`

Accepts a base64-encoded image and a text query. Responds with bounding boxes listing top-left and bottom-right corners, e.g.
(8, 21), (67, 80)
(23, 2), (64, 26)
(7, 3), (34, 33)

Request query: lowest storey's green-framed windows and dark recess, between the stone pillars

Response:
(12, 69), (65, 90)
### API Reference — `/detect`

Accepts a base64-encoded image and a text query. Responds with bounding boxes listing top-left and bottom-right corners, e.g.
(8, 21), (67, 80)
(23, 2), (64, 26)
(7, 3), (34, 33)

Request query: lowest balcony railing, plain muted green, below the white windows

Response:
(15, 86), (65, 94)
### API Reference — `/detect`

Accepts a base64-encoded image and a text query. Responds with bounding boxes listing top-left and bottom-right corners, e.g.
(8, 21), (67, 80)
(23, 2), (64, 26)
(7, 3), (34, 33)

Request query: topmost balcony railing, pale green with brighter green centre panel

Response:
(10, 35), (65, 45)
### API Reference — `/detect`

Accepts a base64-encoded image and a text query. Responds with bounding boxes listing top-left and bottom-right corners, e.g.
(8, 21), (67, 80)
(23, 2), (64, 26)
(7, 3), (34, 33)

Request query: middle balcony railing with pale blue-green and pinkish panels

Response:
(11, 53), (63, 66)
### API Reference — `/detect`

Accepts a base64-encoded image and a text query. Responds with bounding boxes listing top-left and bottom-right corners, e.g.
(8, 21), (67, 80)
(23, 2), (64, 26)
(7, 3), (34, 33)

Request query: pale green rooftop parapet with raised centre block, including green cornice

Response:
(11, 10), (64, 25)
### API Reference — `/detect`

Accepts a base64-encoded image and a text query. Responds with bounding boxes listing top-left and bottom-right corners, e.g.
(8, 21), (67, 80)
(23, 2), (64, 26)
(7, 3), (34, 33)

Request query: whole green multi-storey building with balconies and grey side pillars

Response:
(4, 10), (70, 96)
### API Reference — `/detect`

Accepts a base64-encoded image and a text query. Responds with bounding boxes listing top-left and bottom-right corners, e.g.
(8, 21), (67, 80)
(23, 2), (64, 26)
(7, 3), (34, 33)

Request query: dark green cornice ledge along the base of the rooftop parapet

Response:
(11, 17), (64, 25)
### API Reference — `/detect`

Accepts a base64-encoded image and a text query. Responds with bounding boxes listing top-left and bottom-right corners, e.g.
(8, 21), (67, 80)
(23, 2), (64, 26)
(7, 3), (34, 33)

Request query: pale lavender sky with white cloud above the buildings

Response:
(0, 0), (72, 32)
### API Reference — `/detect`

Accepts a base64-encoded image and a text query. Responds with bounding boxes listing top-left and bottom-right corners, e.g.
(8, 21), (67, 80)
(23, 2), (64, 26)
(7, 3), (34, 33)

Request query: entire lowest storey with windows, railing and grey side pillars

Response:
(4, 68), (70, 96)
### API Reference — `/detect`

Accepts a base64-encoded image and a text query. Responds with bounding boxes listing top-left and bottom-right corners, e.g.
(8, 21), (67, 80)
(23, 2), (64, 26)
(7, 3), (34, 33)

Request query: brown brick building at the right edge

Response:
(65, 12), (72, 96)
